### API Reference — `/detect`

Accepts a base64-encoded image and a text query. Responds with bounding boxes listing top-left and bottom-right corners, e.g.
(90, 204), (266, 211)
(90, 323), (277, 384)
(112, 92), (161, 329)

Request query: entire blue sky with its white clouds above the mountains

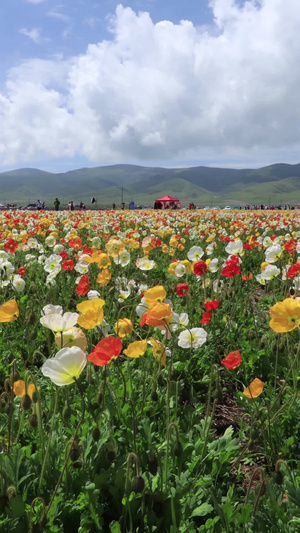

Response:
(0, 0), (300, 172)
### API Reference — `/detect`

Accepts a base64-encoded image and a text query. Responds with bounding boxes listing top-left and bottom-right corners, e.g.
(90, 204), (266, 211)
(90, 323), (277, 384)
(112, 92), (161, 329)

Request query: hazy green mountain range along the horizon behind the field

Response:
(0, 163), (300, 207)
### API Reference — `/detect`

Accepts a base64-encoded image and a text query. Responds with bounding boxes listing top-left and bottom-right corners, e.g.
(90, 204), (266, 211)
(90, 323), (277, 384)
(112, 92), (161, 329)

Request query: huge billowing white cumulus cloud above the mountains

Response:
(0, 0), (300, 164)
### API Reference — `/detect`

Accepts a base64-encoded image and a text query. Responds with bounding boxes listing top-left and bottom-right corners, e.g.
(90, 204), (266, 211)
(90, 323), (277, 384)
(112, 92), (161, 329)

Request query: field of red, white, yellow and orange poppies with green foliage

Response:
(0, 210), (300, 533)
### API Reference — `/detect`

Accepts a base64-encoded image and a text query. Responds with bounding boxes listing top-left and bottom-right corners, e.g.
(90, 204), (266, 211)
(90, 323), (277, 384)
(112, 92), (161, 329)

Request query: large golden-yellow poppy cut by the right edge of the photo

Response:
(269, 298), (300, 333)
